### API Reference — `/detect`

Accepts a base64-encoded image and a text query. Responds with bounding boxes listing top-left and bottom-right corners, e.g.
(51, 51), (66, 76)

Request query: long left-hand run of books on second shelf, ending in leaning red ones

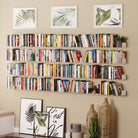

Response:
(7, 49), (81, 62)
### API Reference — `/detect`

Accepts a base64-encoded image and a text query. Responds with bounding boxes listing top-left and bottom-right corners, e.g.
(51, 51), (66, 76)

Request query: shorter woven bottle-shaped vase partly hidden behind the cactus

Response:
(85, 104), (97, 135)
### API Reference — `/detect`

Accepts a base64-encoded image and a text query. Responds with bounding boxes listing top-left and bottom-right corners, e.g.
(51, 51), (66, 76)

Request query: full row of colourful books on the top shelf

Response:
(7, 34), (117, 48)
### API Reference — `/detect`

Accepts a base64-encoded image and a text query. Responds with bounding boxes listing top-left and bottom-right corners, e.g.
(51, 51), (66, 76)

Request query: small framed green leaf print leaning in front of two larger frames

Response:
(34, 111), (49, 136)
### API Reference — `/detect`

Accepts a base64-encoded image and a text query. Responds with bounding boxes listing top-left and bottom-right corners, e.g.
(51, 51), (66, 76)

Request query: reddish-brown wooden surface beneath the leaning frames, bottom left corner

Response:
(0, 133), (54, 138)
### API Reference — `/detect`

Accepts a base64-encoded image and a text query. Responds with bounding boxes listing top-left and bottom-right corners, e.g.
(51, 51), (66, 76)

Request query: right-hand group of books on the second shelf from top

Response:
(84, 49), (126, 64)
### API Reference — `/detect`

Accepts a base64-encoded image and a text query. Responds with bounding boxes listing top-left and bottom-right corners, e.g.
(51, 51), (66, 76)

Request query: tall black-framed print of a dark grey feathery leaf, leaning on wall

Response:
(20, 98), (42, 134)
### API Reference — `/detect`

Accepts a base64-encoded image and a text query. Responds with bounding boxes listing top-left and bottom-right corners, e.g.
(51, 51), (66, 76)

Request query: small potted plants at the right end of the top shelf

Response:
(115, 35), (127, 47)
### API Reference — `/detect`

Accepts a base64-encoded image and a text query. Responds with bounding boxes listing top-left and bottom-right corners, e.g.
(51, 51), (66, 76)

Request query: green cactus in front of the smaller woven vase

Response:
(89, 116), (98, 138)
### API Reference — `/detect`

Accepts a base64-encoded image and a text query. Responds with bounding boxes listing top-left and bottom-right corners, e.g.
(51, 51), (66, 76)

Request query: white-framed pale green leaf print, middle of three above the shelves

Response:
(51, 6), (77, 28)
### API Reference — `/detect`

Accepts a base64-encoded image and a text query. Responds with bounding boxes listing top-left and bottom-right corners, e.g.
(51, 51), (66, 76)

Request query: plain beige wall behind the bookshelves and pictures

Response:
(0, 0), (138, 138)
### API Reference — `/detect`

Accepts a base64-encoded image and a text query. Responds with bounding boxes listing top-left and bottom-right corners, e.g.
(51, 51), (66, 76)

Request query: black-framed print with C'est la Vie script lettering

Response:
(46, 106), (66, 138)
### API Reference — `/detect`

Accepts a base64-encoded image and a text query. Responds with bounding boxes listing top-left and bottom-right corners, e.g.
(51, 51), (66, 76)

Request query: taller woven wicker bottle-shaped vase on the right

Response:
(98, 98), (113, 138)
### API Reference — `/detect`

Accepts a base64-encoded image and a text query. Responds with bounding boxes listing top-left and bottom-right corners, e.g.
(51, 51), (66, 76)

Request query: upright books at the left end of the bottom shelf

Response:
(7, 77), (51, 91)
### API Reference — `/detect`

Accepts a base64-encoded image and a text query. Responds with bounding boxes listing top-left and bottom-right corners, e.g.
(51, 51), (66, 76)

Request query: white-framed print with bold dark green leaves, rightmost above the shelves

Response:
(94, 4), (122, 27)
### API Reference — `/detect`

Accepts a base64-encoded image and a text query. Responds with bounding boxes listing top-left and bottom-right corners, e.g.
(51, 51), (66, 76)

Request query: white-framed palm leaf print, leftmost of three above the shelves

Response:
(13, 8), (36, 29)
